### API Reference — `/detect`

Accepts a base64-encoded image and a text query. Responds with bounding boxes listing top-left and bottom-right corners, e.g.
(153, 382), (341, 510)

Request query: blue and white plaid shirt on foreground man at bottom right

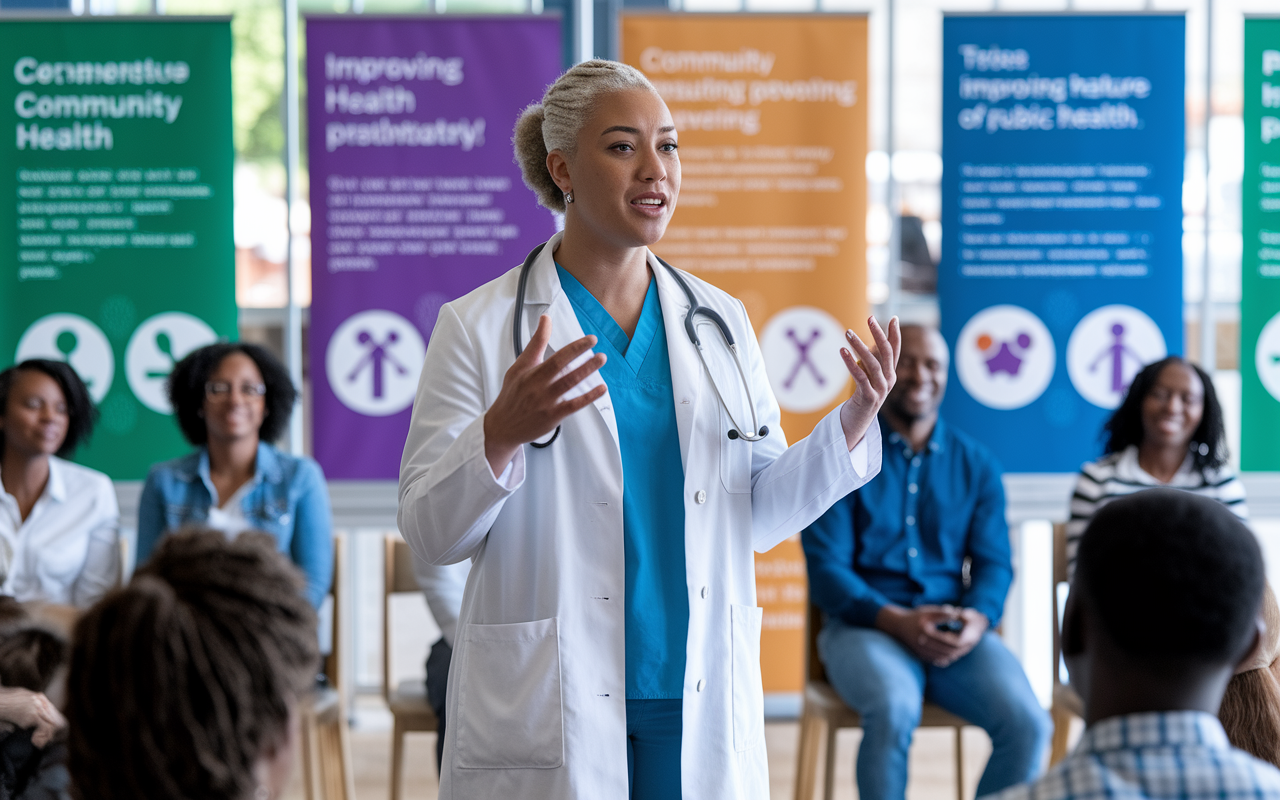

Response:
(988, 712), (1280, 800)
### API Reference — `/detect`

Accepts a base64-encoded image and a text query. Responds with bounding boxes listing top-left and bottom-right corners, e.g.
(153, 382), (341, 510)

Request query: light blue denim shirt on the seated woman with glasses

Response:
(138, 443), (333, 608)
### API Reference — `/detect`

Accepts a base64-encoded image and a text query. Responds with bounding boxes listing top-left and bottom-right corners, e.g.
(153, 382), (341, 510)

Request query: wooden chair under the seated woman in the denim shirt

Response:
(301, 535), (356, 800)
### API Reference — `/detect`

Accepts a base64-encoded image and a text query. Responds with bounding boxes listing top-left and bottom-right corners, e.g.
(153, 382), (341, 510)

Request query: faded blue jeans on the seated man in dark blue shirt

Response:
(818, 620), (1053, 800)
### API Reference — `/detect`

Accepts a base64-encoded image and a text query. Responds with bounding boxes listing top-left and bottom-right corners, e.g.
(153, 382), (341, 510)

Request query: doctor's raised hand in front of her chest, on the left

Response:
(484, 314), (605, 476)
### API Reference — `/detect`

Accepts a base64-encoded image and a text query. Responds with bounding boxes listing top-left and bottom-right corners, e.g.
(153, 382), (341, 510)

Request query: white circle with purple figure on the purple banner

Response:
(324, 310), (426, 417)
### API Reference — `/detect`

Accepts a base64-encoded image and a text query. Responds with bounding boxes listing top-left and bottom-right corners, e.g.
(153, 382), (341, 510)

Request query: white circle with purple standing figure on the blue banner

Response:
(1066, 306), (1169, 408)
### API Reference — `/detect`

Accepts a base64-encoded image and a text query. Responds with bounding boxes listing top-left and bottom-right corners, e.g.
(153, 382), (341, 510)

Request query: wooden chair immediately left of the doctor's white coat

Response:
(383, 535), (438, 800)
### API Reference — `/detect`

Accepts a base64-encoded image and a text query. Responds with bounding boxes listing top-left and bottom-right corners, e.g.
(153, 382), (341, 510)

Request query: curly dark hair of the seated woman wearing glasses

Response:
(168, 342), (298, 447)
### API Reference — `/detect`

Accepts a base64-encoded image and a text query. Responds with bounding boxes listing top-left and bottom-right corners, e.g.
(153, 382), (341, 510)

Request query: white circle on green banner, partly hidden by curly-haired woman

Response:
(124, 311), (218, 413)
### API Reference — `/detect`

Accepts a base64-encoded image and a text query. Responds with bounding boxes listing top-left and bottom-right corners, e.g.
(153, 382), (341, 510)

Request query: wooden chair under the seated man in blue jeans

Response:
(795, 603), (968, 800)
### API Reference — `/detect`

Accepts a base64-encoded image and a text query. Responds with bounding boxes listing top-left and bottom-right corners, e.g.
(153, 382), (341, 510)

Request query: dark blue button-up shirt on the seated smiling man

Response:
(800, 419), (1014, 627)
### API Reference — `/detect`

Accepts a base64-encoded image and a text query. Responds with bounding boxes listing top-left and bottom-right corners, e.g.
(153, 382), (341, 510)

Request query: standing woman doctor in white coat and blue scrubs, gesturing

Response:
(399, 60), (900, 800)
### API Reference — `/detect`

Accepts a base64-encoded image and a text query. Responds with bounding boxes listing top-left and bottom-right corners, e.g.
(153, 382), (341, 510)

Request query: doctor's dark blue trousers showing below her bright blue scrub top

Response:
(627, 700), (685, 800)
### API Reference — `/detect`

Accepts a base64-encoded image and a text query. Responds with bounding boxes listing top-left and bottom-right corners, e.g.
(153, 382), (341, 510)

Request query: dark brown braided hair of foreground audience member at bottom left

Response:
(67, 527), (319, 800)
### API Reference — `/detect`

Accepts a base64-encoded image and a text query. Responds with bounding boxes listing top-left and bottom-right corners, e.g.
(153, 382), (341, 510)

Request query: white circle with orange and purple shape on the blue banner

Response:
(955, 306), (1057, 411)
